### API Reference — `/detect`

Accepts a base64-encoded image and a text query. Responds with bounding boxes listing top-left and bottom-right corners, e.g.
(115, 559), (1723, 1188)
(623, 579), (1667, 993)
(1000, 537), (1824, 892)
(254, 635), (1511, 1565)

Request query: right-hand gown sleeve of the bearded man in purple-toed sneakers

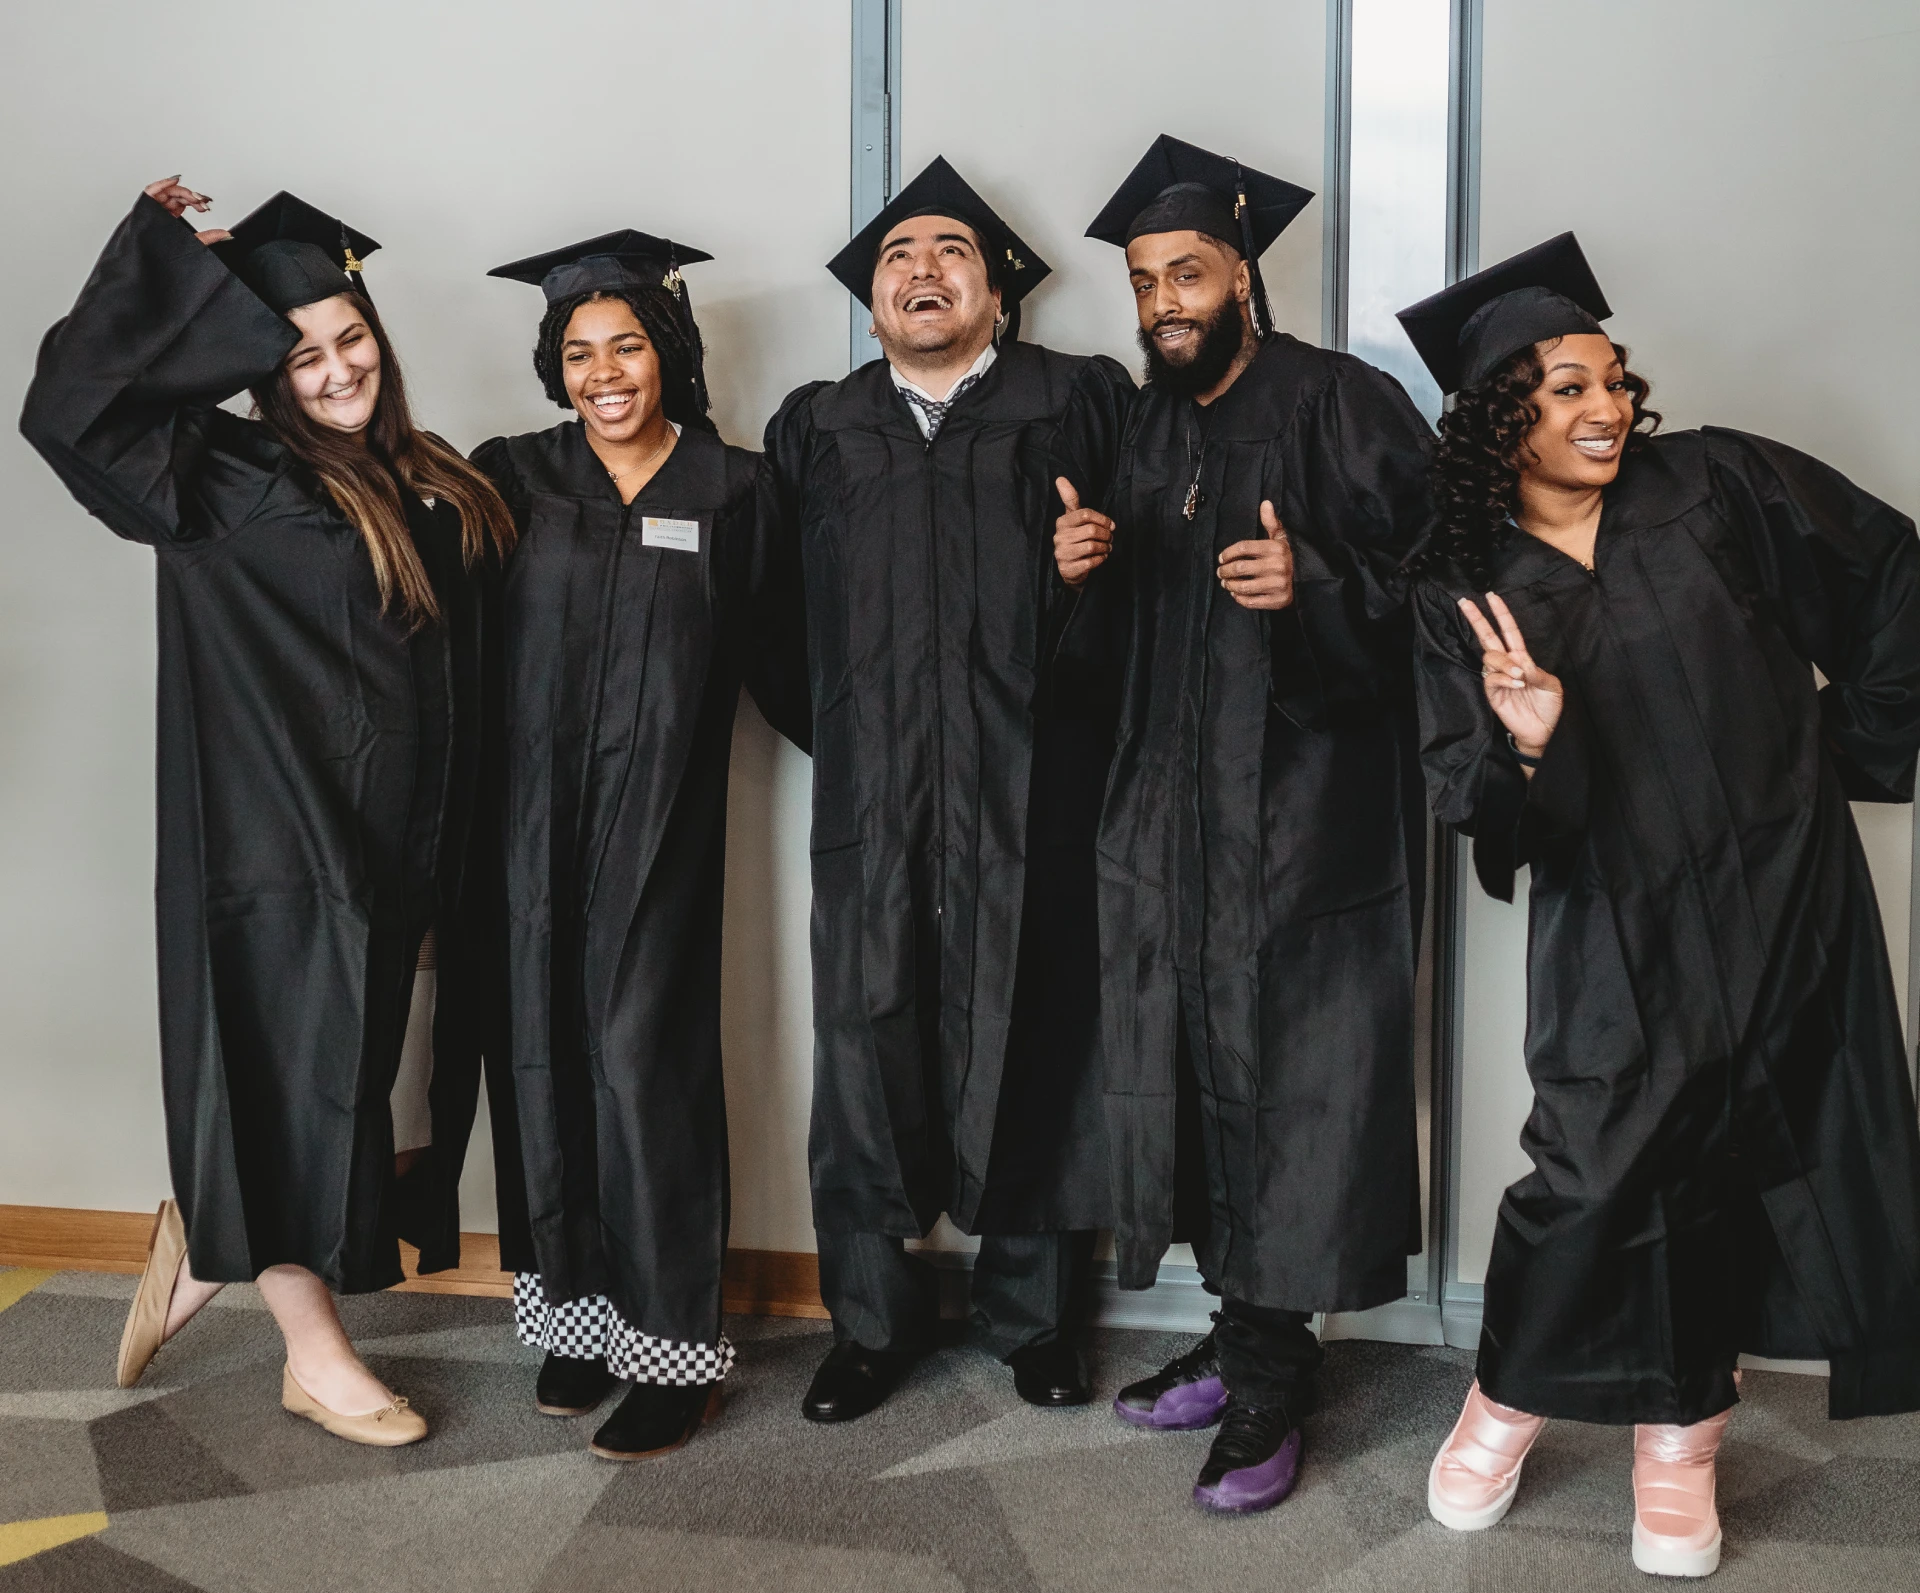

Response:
(1271, 359), (1434, 727)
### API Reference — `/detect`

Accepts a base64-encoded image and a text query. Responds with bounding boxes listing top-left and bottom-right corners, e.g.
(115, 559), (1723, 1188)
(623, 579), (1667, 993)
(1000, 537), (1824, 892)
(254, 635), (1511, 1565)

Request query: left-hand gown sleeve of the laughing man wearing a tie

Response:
(743, 382), (828, 754)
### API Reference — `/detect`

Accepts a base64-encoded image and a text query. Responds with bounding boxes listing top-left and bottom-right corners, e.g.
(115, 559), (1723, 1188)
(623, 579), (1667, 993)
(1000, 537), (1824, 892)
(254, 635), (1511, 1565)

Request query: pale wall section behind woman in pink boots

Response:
(1459, 0), (1920, 1282)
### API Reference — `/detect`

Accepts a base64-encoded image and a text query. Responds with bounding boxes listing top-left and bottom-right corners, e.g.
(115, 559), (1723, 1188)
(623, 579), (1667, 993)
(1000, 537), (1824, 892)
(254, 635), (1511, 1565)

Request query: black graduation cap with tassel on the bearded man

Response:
(1087, 132), (1313, 338)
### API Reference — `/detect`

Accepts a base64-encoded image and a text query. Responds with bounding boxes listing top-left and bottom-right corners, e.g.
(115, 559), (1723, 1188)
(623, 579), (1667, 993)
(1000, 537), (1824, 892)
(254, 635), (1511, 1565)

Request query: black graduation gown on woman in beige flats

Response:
(21, 198), (518, 1294)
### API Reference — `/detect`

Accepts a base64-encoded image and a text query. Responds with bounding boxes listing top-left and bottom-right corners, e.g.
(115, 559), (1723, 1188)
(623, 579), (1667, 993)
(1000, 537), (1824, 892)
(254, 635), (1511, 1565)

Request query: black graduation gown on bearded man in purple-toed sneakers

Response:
(1094, 334), (1430, 1311)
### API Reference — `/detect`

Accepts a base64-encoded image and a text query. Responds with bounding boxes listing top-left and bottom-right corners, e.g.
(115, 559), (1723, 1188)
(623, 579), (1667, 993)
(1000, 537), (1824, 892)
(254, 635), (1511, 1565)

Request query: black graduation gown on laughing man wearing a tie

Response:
(766, 344), (1133, 1236)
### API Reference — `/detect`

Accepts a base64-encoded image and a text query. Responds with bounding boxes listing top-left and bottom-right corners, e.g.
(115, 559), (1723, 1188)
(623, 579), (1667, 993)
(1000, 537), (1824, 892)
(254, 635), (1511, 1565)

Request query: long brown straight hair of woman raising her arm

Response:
(253, 292), (515, 628)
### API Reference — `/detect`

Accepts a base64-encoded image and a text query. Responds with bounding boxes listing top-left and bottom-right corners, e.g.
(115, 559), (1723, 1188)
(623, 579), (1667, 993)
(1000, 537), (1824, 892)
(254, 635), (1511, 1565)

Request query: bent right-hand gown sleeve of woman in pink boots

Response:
(1703, 428), (1920, 802)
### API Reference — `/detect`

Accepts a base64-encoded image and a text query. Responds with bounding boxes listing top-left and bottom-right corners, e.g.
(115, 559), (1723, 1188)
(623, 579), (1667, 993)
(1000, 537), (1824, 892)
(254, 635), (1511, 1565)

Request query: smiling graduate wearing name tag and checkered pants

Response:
(474, 232), (810, 1461)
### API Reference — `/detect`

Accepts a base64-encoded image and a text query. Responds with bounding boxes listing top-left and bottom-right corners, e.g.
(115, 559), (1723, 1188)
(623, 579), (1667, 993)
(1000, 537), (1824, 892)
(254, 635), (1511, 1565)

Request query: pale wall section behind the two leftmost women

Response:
(0, 0), (851, 1249)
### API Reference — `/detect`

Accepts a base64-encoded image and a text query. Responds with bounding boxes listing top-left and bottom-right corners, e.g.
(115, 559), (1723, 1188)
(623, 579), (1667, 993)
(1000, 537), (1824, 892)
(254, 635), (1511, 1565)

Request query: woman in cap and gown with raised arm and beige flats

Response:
(21, 178), (533, 1445)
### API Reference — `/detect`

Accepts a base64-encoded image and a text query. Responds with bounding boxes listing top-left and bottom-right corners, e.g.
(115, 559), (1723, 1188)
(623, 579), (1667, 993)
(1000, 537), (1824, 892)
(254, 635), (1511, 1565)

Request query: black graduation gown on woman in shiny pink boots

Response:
(1417, 430), (1920, 1422)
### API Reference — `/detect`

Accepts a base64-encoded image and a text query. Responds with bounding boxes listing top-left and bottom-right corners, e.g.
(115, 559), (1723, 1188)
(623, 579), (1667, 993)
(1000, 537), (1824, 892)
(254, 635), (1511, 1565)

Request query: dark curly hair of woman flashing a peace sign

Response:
(1409, 344), (1661, 585)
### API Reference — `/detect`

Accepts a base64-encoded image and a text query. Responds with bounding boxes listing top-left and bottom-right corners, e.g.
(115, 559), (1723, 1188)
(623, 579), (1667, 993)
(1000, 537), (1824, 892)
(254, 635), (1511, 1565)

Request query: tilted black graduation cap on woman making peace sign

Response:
(1398, 232), (1613, 393)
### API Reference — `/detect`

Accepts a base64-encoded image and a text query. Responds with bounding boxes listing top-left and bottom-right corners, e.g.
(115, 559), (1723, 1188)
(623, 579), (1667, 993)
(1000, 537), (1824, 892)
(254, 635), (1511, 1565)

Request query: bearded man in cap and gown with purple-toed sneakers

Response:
(1054, 136), (1430, 1510)
